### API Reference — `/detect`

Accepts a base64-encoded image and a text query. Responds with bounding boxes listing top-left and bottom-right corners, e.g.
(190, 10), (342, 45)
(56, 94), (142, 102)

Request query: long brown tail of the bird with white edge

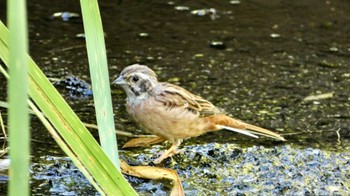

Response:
(211, 115), (286, 141)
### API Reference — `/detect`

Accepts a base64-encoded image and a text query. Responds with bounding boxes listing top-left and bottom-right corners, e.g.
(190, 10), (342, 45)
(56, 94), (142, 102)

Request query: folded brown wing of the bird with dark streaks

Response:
(156, 82), (221, 117)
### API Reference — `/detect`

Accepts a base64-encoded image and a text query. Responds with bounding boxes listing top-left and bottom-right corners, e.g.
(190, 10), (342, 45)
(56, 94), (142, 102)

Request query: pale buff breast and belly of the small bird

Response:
(127, 98), (207, 140)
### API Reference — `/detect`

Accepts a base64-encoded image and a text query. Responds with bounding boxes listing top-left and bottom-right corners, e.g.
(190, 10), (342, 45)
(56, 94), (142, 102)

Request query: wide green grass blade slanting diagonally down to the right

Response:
(0, 20), (136, 195)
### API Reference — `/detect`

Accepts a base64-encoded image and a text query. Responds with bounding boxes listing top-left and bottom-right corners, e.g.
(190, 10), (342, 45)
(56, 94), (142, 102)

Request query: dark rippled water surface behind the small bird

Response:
(0, 0), (350, 194)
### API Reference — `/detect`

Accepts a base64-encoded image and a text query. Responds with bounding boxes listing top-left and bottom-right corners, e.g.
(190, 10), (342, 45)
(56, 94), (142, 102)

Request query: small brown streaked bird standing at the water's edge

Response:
(113, 64), (285, 164)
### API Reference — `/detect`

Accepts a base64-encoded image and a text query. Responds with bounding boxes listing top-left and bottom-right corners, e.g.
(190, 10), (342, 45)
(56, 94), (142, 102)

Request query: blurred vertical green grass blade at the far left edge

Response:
(7, 0), (30, 196)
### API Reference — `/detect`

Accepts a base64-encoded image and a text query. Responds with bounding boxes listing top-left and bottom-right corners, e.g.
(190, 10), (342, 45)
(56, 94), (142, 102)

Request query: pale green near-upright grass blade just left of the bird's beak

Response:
(80, 0), (120, 169)
